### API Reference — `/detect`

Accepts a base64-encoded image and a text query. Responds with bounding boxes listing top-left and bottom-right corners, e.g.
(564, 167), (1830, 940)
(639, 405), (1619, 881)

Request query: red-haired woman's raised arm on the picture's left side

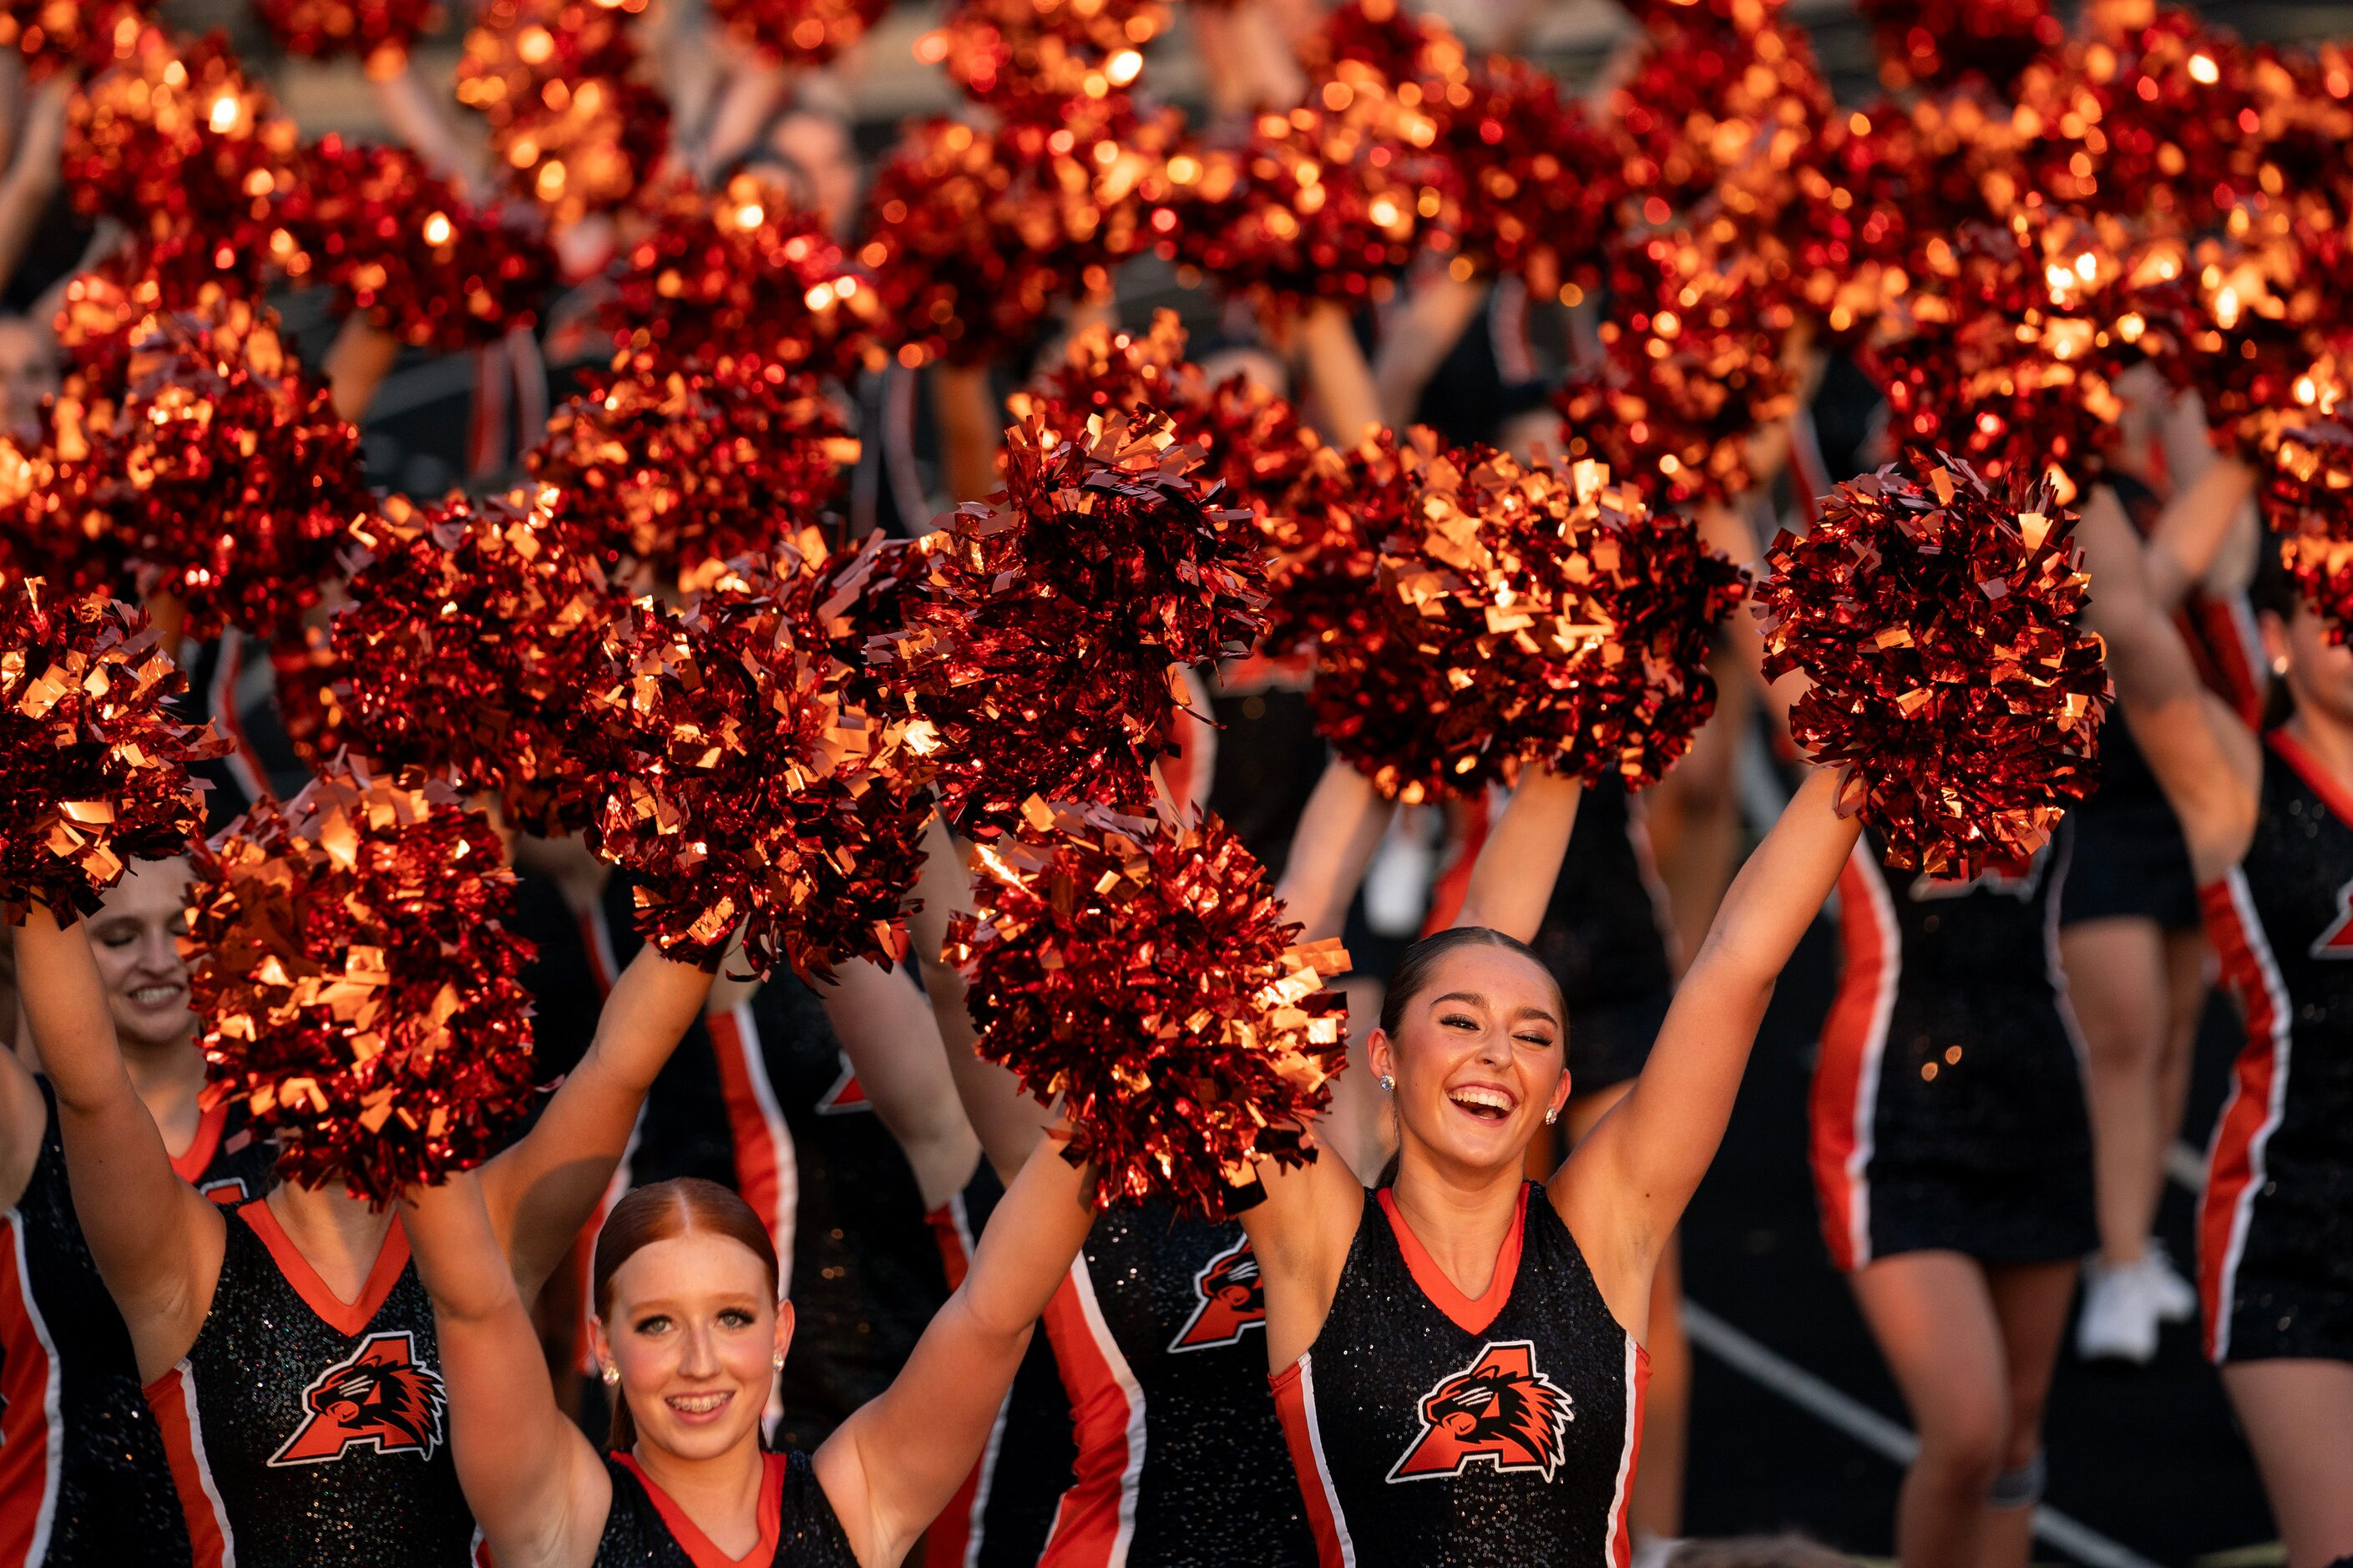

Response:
(400, 1172), (612, 1568)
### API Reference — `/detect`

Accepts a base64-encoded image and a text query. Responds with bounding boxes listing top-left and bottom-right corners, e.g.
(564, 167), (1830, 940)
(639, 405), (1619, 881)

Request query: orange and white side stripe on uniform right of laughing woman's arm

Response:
(1807, 841), (1904, 1272)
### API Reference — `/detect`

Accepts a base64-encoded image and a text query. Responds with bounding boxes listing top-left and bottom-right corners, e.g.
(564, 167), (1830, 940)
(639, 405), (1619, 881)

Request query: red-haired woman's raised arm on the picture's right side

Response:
(817, 1140), (1094, 1563)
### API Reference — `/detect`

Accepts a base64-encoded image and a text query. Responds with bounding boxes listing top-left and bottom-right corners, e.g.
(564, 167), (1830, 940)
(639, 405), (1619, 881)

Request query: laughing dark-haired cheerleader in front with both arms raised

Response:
(1242, 757), (1859, 1568)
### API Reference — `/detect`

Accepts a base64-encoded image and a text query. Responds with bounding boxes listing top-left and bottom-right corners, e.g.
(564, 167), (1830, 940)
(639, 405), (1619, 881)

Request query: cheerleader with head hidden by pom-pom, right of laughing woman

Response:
(1809, 833), (2097, 1568)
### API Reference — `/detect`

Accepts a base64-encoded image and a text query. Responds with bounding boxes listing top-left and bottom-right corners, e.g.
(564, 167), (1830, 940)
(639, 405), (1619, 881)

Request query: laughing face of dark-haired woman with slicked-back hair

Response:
(1367, 937), (1570, 1177)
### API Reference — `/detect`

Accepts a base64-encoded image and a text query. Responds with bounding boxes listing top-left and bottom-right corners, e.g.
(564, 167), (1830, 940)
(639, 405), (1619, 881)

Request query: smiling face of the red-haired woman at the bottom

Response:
(593, 1229), (793, 1462)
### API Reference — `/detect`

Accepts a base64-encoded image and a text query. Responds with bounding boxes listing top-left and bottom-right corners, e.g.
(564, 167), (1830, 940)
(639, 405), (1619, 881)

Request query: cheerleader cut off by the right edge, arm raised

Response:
(2082, 492), (2353, 1568)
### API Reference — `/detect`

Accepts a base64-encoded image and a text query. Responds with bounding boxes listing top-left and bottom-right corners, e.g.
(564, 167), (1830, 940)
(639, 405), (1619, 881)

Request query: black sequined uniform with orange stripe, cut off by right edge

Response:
(2198, 732), (2353, 1361)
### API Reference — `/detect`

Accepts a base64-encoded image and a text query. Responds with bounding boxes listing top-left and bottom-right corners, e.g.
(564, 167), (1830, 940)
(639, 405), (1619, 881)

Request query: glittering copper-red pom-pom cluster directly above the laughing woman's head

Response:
(1315, 450), (1743, 801)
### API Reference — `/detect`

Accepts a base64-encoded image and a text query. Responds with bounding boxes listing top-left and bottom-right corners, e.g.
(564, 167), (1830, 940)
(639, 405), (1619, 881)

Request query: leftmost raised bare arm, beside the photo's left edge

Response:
(17, 904), (226, 1378)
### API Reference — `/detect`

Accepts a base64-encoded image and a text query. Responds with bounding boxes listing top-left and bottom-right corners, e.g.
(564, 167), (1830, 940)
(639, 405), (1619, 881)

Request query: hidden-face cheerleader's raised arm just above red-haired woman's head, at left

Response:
(480, 944), (711, 1297)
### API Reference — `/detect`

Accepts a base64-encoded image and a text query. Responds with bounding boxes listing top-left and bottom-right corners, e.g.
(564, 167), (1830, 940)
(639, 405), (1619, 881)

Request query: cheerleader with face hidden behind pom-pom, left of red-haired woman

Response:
(17, 908), (711, 1568)
